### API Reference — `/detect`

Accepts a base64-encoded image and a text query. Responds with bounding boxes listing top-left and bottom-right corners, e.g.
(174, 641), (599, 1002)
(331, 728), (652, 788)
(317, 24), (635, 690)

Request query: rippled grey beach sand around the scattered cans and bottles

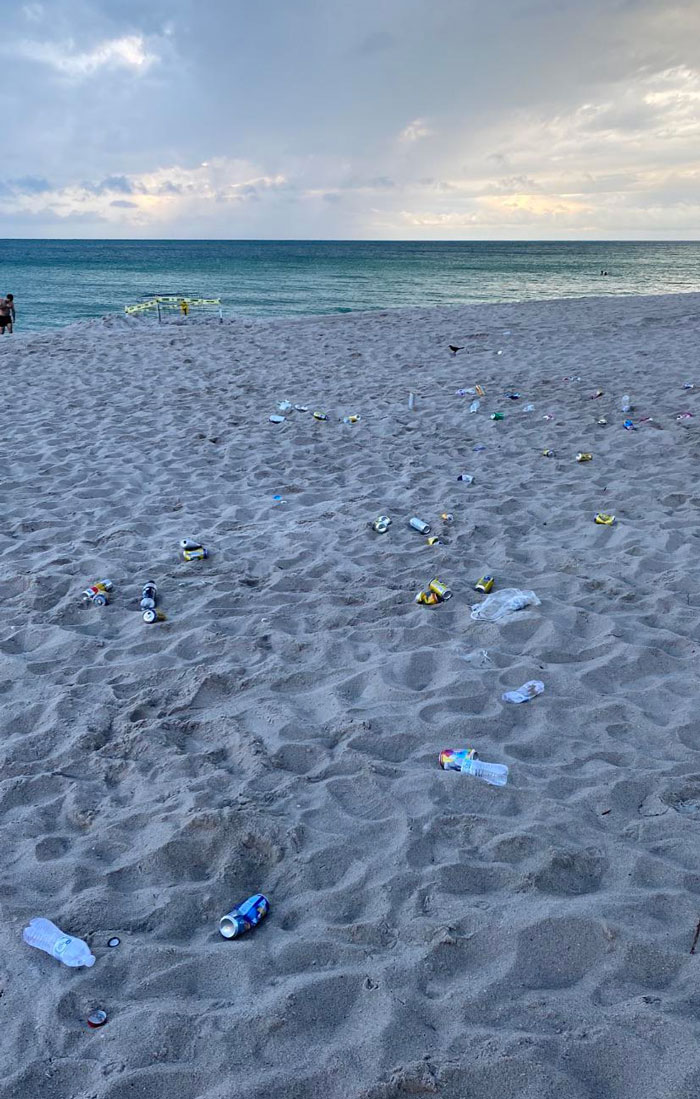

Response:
(0, 295), (700, 1099)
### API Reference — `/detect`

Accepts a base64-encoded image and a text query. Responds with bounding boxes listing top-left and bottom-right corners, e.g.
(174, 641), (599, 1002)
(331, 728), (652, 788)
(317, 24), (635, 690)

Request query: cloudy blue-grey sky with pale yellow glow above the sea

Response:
(0, 0), (700, 240)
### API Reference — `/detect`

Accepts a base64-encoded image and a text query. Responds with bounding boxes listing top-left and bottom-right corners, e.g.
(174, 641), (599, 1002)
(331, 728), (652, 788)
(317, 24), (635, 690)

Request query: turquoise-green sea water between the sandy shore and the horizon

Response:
(0, 241), (700, 331)
